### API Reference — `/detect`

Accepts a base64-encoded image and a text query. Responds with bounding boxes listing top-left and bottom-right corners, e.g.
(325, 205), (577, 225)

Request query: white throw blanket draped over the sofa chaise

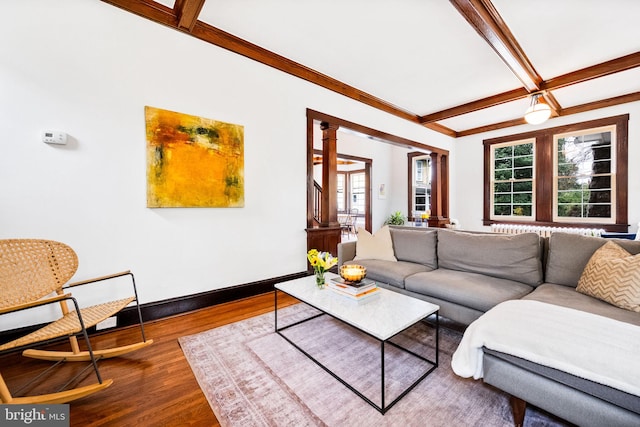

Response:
(451, 300), (640, 396)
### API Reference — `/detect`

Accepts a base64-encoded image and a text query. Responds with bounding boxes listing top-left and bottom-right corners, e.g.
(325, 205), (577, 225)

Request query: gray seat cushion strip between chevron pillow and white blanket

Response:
(522, 283), (640, 326)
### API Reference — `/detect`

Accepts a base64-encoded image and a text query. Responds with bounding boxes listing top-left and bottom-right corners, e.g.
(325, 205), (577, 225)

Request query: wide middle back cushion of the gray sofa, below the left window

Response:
(438, 230), (542, 286)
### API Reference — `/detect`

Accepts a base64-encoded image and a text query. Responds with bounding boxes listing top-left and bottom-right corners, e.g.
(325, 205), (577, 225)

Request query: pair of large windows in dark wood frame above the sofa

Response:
(483, 115), (629, 232)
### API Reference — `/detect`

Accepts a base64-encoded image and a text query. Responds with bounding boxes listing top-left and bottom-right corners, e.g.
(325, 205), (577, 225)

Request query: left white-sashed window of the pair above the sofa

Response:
(491, 139), (535, 220)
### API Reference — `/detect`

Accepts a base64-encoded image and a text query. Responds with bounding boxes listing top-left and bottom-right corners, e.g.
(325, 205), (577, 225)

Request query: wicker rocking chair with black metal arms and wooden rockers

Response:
(0, 239), (153, 404)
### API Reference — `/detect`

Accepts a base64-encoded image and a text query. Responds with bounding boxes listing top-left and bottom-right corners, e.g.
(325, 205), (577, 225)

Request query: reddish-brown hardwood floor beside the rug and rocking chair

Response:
(0, 293), (297, 427)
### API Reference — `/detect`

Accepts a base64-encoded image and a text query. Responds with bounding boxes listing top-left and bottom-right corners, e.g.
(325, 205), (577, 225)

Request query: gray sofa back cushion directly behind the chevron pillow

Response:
(545, 233), (640, 287)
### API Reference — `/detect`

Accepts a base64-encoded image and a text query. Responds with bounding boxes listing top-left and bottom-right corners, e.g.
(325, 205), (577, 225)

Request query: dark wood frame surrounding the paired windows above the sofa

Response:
(483, 114), (629, 233)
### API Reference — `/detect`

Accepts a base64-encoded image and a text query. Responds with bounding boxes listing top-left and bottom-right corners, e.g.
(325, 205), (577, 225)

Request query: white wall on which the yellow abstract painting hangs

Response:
(0, 0), (454, 314)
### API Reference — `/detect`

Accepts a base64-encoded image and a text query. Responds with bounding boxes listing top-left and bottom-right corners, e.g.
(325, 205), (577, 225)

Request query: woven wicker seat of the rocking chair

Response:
(0, 297), (135, 351)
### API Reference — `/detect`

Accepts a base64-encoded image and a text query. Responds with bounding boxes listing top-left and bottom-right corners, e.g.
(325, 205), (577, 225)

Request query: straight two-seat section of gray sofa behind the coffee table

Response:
(338, 227), (544, 325)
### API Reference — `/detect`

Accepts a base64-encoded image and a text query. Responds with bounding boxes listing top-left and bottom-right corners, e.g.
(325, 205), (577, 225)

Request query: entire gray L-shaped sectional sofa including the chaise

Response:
(338, 227), (640, 426)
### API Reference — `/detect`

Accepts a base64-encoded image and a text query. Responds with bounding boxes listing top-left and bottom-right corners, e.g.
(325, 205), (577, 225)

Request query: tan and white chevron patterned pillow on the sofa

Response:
(576, 242), (640, 313)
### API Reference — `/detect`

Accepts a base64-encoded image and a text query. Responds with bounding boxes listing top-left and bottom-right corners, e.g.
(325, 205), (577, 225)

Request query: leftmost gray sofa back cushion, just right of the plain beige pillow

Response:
(391, 228), (438, 269)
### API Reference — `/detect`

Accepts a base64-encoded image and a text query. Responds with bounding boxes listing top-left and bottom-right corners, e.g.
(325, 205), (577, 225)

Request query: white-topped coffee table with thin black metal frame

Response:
(274, 273), (440, 414)
